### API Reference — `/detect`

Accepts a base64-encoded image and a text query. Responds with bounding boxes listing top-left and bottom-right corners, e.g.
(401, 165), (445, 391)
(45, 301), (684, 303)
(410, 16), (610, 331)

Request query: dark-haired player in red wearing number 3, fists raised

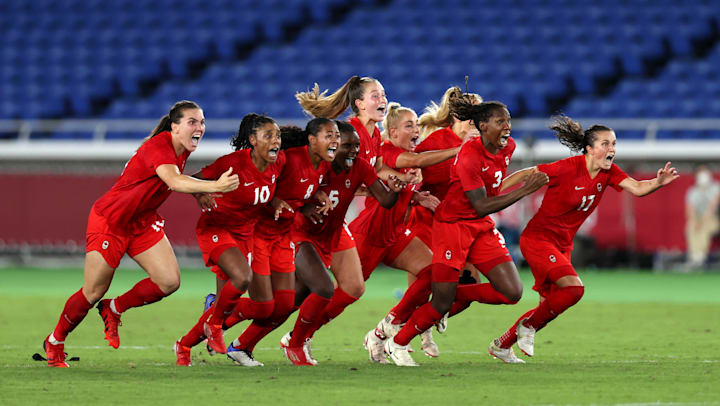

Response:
(383, 100), (548, 366)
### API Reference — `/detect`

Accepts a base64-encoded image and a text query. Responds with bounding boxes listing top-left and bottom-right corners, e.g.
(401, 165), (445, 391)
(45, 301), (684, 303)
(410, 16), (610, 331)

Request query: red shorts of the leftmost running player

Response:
(85, 206), (165, 268)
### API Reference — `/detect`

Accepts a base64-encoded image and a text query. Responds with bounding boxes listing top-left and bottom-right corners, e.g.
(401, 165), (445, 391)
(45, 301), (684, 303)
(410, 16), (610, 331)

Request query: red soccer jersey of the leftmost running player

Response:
(95, 131), (190, 234)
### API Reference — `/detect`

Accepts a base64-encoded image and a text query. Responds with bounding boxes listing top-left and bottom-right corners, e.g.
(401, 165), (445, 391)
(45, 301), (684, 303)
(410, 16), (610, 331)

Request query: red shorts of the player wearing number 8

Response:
(252, 232), (295, 275)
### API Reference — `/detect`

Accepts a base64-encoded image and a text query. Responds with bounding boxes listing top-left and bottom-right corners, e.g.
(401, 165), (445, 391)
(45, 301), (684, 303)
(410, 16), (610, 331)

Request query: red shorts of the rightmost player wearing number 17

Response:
(520, 236), (578, 297)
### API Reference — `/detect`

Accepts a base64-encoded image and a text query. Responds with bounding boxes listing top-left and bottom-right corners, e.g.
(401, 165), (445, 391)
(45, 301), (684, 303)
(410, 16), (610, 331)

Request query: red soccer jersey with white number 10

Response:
(198, 149), (285, 238)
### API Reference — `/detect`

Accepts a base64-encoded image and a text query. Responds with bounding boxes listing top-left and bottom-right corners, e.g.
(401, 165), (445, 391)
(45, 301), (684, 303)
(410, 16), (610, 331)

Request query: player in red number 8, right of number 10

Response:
(222, 118), (338, 366)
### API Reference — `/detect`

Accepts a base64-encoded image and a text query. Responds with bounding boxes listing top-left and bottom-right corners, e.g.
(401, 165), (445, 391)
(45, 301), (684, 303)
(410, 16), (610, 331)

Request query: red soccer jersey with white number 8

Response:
(256, 146), (330, 236)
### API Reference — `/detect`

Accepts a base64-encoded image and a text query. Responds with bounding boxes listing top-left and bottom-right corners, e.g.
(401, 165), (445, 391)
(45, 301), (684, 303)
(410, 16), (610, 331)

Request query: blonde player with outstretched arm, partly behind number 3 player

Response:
(350, 103), (460, 362)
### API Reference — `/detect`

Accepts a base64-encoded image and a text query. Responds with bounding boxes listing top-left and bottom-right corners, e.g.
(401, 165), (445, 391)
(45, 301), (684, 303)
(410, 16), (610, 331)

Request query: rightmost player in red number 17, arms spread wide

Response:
(489, 116), (680, 363)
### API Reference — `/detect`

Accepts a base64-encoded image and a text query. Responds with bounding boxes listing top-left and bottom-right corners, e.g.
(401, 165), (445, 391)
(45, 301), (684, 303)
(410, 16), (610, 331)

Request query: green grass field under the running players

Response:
(0, 269), (720, 405)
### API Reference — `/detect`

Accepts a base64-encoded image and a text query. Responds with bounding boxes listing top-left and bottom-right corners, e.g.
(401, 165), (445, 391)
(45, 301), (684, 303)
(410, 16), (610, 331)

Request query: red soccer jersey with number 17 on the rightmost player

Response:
(523, 155), (628, 251)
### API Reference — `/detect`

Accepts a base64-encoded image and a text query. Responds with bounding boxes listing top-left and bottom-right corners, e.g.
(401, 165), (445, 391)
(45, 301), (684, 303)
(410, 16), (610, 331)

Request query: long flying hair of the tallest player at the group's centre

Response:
(295, 75), (377, 119)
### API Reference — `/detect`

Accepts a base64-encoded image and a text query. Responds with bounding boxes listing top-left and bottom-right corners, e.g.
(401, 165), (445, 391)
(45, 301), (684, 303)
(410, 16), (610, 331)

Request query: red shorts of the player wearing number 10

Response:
(195, 225), (252, 280)
